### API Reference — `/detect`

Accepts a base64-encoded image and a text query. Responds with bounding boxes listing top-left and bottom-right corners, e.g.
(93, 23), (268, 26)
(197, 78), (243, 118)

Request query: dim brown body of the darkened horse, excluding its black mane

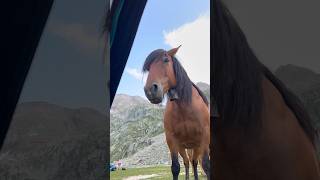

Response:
(213, 77), (318, 177)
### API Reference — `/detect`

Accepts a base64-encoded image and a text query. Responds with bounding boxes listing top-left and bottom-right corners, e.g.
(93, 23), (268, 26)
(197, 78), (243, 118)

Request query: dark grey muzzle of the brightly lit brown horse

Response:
(144, 83), (163, 104)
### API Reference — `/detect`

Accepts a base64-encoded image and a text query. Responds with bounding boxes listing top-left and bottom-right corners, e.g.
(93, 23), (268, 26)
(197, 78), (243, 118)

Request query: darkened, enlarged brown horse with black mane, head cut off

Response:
(211, 0), (320, 180)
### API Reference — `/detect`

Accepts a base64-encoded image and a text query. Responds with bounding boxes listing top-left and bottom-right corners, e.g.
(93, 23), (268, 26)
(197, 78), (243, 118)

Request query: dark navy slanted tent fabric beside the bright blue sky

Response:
(110, 0), (147, 105)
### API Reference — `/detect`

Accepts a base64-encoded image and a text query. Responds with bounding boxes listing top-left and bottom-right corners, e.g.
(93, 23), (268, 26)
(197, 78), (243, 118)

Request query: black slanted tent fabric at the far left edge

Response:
(0, 0), (53, 149)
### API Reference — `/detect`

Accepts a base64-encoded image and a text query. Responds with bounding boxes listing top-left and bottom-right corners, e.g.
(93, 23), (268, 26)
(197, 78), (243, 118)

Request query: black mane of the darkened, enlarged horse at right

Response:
(212, 0), (315, 142)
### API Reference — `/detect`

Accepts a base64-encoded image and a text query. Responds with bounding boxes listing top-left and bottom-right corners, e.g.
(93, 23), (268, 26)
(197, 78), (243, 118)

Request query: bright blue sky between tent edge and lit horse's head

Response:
(117, 0), (210, 97)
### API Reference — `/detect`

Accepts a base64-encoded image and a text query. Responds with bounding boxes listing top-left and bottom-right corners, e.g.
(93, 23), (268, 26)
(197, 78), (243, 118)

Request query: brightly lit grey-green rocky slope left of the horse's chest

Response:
(110, 94), (164, 161)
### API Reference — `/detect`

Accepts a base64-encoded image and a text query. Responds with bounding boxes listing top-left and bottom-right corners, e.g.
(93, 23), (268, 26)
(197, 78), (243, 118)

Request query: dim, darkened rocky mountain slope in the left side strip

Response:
(0, 102), (109, 180)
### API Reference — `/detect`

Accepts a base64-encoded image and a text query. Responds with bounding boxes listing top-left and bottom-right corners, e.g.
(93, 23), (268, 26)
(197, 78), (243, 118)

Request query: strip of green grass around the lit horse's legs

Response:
(110, 166), (206, 180)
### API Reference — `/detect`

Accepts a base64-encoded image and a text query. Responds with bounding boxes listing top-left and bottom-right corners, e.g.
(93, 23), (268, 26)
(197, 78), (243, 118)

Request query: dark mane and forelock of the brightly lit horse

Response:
(142, 49), (209, 106)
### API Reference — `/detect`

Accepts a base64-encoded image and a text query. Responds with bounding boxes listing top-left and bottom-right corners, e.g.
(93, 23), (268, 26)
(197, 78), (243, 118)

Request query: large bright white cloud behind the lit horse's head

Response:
(164, 13), (210, 84)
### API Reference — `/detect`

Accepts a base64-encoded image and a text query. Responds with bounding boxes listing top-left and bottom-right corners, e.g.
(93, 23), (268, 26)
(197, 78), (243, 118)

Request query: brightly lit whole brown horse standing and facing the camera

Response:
(143, 48), (210, 179)
